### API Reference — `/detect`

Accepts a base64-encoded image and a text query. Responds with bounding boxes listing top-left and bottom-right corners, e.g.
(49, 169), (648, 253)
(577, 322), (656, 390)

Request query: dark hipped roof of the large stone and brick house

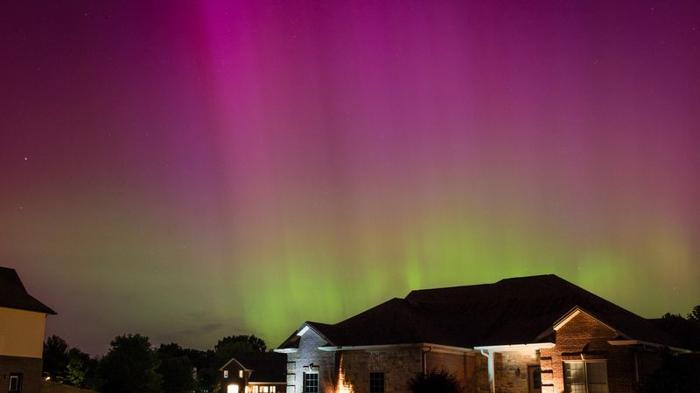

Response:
(282, 274), (678, 348)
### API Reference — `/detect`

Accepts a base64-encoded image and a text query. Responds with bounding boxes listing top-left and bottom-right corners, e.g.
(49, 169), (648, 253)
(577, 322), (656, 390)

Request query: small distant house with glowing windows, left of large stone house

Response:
(219, 352), (287, 393)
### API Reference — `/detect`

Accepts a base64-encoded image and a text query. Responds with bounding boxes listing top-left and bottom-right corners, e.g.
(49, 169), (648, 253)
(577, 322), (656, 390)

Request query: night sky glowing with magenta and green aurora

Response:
(0, 0), (700, 353)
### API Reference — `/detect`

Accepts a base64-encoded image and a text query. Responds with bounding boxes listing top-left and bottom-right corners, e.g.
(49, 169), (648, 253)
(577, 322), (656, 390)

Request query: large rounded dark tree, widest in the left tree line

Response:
(99, 334), (162, 393)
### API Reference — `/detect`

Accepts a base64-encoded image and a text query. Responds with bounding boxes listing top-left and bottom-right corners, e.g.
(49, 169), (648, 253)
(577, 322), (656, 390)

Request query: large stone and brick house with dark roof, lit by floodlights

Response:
(276, 275), (690, 393)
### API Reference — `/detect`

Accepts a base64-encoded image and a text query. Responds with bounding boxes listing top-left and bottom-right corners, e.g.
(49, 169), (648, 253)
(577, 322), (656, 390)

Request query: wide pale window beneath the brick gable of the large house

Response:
(564, 360), (608, 393)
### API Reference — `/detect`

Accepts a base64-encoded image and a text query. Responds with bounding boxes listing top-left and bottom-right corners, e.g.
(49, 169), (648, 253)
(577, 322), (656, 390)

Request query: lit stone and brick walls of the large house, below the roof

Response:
(287, 312), (659, 393)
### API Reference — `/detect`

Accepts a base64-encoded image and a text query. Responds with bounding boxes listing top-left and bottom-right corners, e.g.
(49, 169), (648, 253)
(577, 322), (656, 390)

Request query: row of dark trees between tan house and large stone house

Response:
(43, 334), (267, 393)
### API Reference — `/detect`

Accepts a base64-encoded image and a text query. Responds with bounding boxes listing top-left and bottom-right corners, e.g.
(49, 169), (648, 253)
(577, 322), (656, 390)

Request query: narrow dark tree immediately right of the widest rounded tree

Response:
(156, 343), (195, 393)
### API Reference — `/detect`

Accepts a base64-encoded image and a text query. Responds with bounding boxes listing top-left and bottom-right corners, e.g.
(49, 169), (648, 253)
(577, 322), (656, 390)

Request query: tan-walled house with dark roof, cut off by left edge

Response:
(0, 267), (56, 393)
